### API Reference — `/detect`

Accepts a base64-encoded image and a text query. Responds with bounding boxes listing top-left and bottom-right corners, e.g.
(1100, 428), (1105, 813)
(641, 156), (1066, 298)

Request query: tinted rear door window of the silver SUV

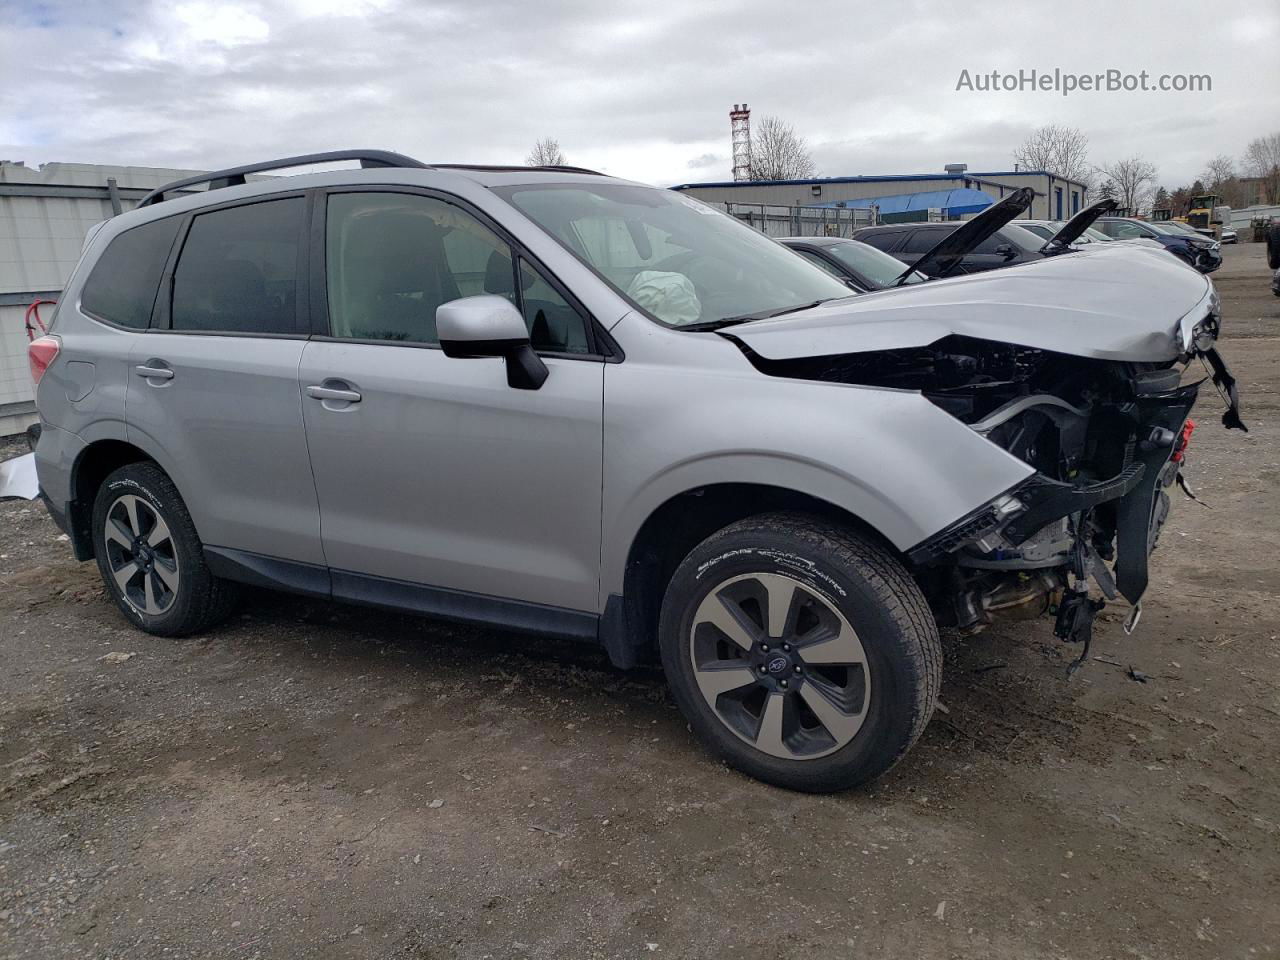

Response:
(172, 197), (306, 334)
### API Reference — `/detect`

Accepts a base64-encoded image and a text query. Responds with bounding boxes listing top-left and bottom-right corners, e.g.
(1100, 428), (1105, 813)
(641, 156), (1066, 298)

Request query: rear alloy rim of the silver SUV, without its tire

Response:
(104, 494), (180, 616)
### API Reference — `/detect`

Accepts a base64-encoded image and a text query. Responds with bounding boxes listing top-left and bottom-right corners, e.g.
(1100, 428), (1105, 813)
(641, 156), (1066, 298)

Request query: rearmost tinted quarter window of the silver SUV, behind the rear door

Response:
(81, 216), (182, 330)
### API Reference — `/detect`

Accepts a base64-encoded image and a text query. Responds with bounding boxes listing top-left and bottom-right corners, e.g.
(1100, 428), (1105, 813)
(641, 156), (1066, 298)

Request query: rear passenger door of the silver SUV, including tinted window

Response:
(125, 195), (324, 563)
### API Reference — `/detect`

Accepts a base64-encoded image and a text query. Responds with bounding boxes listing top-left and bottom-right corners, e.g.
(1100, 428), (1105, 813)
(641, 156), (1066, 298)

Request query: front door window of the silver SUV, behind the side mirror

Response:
(325, 193), (517, 343)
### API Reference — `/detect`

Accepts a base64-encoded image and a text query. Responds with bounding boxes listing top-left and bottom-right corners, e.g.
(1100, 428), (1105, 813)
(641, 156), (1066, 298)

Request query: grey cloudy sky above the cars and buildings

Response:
(0, 0), (1280, 187)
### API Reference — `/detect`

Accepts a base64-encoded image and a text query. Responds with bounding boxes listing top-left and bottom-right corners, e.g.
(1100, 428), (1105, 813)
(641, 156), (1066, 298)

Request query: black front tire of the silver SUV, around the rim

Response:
(659, 513), (942, 792)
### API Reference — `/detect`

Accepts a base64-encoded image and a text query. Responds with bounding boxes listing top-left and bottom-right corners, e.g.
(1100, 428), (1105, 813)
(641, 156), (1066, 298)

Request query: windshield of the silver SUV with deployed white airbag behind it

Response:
(495, 182), (855, 329)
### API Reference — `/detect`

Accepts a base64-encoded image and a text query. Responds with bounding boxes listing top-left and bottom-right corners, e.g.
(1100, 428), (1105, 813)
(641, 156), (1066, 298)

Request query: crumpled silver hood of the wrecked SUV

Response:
(722, 243), (1213, 362)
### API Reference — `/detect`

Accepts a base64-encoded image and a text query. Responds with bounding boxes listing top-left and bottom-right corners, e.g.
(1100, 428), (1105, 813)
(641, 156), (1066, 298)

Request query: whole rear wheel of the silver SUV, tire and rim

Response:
(93, 462), (236, 636)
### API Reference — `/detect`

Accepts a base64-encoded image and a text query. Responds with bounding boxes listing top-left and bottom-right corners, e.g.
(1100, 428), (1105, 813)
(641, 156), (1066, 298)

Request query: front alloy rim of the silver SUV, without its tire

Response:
(689, 573), (872, 760)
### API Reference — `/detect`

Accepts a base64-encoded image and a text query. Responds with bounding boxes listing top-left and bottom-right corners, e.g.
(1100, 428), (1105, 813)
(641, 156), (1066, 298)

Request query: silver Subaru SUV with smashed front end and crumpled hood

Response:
(29, 151), (1243, 791)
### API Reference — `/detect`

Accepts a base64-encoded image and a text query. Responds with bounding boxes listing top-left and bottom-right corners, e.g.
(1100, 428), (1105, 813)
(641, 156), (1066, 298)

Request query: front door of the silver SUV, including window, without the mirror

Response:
(301, 191), (604, 612)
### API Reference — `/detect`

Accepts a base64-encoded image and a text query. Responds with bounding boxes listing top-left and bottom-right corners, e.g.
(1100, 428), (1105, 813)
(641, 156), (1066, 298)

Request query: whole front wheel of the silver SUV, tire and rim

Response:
(659, 515), (942, 792)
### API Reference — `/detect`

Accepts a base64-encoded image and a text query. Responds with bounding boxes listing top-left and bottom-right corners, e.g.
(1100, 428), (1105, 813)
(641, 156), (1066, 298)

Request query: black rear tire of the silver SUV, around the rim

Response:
(93, 462), (239, 636)
